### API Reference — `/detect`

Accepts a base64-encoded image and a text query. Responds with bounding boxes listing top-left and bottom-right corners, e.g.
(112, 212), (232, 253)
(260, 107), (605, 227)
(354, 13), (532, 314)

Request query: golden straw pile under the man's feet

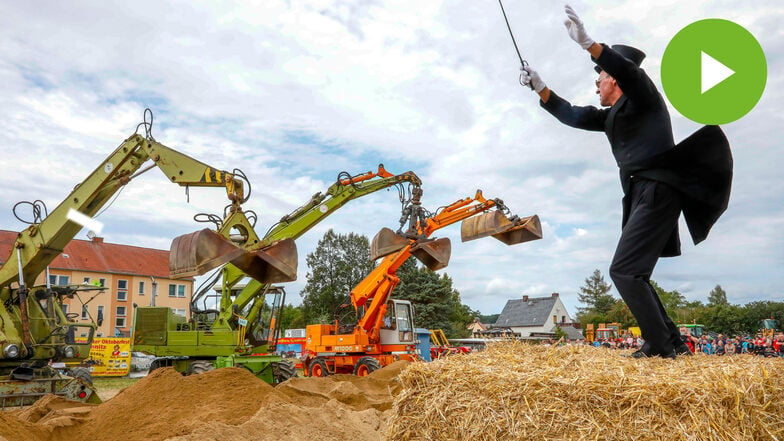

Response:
(386, 343), (784, 441)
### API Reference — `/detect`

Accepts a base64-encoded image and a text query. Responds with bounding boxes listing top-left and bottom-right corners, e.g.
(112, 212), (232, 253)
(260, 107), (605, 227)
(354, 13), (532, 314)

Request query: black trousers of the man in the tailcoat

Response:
(610, 178), (681, 353)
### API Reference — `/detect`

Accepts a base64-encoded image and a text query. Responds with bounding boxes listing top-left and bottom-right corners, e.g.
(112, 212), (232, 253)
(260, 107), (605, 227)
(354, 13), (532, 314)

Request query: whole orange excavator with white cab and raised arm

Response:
(303, 189), (542, 377)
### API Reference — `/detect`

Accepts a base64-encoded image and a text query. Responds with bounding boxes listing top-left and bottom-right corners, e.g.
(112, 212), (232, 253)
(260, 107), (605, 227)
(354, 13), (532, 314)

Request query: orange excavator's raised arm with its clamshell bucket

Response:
(351, 191), (542, 341)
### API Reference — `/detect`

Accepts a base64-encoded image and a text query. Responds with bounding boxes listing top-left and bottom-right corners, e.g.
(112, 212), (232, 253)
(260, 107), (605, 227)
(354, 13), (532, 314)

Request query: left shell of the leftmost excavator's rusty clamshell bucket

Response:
(169, 228), (245, 279)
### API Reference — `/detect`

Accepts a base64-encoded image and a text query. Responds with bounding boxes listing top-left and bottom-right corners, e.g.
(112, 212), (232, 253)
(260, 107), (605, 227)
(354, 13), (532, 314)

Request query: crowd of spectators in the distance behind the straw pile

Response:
(580, 328), (784, 357)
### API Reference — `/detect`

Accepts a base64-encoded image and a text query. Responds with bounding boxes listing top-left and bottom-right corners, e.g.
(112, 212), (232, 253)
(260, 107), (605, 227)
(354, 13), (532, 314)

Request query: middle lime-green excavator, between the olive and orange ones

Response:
(133, 164), (421, 384)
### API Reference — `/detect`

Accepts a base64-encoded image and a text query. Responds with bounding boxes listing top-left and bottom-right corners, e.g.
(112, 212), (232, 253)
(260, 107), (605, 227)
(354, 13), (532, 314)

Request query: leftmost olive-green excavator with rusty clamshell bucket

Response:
(0, 109), (296, 406)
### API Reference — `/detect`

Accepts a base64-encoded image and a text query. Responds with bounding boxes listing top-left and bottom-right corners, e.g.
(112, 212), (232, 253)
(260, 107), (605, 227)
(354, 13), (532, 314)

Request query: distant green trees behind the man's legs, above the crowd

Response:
(577, 269), (784, 335)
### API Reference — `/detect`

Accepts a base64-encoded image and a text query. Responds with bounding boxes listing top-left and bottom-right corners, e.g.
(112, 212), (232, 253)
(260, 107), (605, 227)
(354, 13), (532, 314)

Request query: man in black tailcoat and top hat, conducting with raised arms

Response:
(521, 6), (732, 358)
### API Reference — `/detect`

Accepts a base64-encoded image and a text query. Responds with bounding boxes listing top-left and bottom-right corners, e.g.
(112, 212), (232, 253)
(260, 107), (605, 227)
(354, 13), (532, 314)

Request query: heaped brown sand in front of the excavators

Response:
(0, 362), (407, 441)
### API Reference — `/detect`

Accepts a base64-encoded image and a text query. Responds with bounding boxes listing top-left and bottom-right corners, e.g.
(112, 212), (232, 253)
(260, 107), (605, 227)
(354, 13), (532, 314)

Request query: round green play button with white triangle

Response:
(661, 18), (768, 124)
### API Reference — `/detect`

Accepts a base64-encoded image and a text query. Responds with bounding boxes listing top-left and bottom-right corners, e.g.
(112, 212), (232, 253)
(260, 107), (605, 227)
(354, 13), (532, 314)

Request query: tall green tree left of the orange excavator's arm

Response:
(300, 229), (373, 323)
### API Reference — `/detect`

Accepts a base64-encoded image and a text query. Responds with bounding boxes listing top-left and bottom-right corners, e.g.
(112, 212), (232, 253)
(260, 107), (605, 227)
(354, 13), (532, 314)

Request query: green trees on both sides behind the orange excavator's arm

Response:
(281, 229), (479, 338)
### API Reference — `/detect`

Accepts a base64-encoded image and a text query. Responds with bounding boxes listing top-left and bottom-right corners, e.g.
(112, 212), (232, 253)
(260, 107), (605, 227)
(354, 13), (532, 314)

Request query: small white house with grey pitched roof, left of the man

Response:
(495, 293), (583, 340)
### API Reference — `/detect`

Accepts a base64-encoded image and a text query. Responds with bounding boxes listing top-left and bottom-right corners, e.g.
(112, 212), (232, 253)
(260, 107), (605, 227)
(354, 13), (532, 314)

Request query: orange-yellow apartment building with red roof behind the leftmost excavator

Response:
(0, 230), (194, 337)
